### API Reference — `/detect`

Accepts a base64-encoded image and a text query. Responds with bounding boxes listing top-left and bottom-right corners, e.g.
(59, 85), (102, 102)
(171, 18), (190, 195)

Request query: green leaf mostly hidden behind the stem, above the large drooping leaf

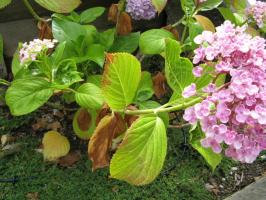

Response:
(137, 100), (169, 127)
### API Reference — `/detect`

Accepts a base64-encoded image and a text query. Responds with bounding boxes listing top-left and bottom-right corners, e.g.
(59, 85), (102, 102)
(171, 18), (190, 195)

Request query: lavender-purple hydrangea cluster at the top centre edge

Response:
(126, 0), (156, 20)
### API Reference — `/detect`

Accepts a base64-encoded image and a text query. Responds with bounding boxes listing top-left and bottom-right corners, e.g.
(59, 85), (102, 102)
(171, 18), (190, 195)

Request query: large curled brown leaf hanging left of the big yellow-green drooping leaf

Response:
(88, 114), (126, 171)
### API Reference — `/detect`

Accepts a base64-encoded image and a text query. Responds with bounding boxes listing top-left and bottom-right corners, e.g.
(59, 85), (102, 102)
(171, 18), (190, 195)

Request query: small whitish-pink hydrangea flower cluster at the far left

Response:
(19, 39), (57, 64)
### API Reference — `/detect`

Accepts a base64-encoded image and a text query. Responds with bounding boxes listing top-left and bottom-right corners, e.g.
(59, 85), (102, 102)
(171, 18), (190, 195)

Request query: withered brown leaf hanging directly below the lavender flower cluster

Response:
(116, 12), (132, 35)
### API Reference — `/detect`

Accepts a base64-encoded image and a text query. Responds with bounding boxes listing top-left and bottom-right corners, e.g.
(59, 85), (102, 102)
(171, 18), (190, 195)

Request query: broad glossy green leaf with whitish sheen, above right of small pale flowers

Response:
(52, 18), (87, 42)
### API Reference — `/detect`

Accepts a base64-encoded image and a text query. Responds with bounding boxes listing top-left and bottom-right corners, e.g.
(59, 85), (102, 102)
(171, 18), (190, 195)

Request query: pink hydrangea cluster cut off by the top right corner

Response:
(246, 1), (266, 28)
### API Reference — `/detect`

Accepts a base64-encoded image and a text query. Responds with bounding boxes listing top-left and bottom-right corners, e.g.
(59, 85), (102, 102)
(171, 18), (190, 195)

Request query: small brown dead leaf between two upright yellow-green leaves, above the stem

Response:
(152, 72), (167, 99)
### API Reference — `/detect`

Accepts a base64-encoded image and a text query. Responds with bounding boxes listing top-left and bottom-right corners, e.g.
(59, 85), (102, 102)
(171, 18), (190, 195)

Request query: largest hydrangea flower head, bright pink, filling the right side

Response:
(183, 21), (266, 163)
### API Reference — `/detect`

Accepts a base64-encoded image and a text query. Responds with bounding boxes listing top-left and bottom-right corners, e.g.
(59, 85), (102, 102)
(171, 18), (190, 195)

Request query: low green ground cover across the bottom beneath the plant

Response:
(0, 111), (233, 200)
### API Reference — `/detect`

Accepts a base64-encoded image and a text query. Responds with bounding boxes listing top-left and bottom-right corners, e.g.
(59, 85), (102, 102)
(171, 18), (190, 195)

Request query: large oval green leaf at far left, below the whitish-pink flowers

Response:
(5, 78), (53, 116)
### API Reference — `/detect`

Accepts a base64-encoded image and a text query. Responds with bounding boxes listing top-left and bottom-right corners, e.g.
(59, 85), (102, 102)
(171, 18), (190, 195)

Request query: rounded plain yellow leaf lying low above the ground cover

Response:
(42, 131), (70, 161)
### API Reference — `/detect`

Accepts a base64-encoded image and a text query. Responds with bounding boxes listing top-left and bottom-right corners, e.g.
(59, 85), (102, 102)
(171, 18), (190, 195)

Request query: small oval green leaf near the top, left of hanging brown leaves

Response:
(80, 7), (105, 24)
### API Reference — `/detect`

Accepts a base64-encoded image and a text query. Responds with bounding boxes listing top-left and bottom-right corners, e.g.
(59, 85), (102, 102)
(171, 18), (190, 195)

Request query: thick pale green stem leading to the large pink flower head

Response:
(123, 97), (202, 115)
